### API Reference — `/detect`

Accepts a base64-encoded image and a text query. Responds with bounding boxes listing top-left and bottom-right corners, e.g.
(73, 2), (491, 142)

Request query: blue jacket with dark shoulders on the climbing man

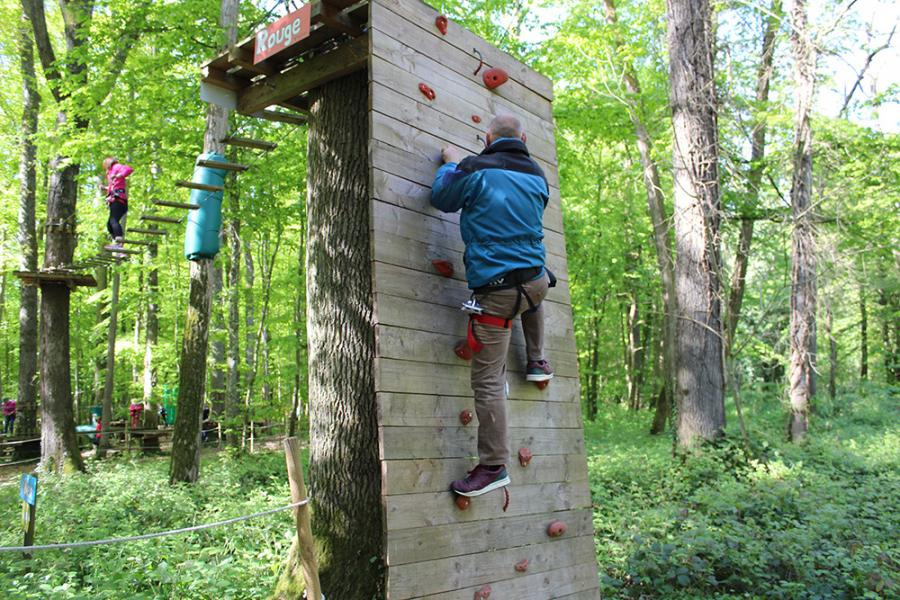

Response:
(431, 138), (550, 289)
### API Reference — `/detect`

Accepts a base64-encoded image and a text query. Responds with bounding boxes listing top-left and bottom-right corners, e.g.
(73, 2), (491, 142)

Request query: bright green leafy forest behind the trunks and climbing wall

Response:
(0, 0), (900, 593)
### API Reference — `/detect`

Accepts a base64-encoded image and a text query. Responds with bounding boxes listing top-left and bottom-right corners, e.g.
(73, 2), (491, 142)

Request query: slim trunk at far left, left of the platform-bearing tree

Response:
(16, 8), (41, 440)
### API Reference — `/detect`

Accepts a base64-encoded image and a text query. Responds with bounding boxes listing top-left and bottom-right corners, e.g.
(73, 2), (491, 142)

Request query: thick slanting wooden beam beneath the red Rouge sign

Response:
(238, 34), (369, 114)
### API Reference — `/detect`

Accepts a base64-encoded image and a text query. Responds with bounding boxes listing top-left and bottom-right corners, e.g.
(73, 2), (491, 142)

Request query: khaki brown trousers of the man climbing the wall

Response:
(472, 272), (550, 466)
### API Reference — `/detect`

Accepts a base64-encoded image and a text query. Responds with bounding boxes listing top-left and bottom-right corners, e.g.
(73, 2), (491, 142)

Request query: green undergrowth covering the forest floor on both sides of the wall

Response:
(0, 388), (900, 600)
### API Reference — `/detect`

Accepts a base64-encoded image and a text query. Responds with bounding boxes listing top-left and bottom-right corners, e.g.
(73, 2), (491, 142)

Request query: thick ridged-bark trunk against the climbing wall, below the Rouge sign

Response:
(282, 71), (384, 599)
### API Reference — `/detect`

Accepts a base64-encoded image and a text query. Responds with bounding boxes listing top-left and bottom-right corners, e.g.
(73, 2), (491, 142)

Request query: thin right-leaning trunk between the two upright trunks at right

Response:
(725, 0), (781, 361)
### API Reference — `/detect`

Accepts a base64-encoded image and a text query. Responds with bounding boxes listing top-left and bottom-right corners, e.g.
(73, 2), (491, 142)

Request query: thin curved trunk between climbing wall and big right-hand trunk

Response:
(604, 0), (677, 433)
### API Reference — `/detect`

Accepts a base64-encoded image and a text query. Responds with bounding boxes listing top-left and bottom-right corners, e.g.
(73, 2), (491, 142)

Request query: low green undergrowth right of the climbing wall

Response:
(587, 389), (900, 598)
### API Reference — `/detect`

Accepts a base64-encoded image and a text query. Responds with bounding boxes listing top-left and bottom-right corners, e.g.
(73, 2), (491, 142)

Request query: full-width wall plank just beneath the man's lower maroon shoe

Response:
(384, 481), (591, 532)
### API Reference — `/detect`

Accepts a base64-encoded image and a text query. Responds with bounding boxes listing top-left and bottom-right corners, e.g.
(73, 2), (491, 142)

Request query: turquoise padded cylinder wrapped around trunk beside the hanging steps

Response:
(184, 152), (227, 260)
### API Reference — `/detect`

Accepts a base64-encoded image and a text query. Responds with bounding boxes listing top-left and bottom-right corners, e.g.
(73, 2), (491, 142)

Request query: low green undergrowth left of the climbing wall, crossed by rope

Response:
(0, 452), (295, 600)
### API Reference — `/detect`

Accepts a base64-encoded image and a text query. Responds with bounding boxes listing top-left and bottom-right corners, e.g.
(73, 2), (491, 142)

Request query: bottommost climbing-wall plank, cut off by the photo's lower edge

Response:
(419, 557), (600, 600)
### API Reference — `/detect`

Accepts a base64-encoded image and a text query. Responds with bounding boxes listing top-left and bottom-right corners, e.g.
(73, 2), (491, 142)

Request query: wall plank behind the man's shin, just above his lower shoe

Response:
(380, 426), (584, 460)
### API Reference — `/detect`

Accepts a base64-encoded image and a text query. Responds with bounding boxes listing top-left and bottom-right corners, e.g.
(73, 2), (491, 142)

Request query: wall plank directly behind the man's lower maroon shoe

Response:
(381, 448), (588, 494)
